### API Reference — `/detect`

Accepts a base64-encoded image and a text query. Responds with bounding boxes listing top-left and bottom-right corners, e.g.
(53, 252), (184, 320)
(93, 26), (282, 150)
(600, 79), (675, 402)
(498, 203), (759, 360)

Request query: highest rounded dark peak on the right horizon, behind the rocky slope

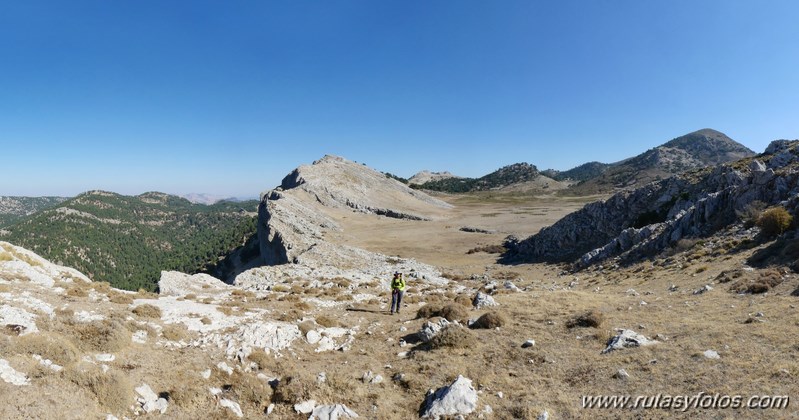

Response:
(562, 128), (755, 195)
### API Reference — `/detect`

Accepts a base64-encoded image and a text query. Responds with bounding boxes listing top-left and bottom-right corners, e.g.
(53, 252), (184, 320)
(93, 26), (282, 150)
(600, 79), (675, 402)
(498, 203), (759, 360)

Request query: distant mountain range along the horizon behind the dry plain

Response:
(411, 129), (755, 195)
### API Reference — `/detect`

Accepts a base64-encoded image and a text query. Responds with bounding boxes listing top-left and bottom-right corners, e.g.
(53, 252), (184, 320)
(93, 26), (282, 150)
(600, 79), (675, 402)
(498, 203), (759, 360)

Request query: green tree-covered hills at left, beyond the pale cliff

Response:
(0, 191), (258, 290)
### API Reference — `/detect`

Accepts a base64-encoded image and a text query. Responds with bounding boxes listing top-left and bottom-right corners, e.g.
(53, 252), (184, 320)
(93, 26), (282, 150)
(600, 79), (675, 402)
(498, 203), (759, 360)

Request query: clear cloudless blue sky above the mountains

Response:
(0, 0), (799, 196)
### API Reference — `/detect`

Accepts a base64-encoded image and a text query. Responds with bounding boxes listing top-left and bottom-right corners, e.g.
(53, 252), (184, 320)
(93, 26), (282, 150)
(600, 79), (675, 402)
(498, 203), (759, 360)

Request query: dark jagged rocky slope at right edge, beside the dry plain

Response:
(504, 141), (799, 267)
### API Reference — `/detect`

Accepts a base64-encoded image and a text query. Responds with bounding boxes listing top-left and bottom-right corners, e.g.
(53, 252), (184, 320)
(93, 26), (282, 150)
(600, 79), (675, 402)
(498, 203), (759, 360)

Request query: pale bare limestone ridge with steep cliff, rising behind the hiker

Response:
(235, 156), (450, 289)
